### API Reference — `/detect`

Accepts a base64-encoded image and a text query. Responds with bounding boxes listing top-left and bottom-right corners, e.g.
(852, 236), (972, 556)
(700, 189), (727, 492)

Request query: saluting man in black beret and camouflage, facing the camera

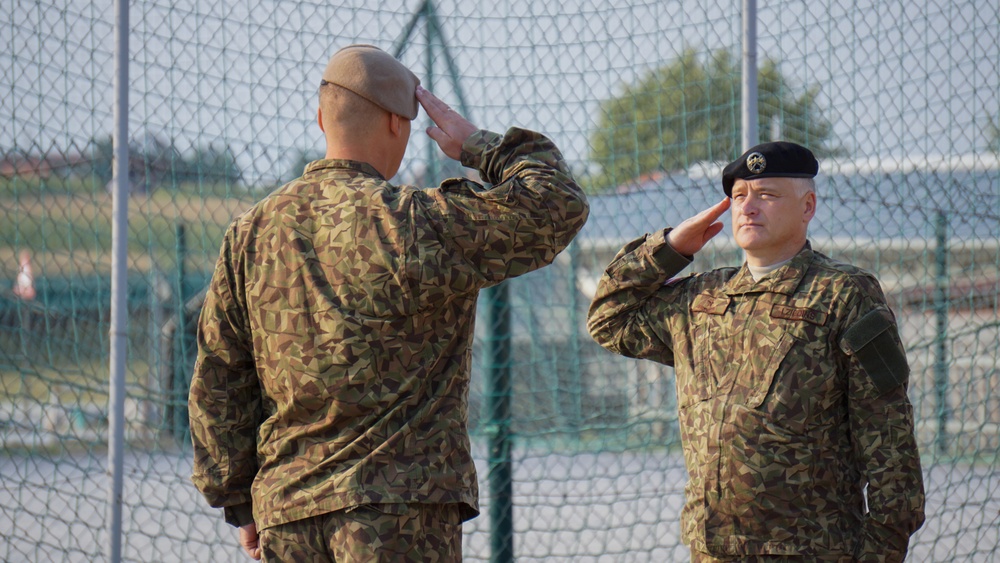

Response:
(588, 142), (924, 563)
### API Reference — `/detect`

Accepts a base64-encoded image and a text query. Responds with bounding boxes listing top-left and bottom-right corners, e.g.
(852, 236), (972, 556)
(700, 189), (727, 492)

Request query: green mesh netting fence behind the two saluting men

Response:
(0, 0), (1000, 562)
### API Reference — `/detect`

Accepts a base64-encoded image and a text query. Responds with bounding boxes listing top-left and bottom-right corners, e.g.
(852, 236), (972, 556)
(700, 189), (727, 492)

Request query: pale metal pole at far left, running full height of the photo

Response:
(108, 0), (129, 563)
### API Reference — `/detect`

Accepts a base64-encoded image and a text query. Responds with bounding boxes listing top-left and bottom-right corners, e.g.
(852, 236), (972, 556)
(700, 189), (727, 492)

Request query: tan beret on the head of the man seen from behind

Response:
(323, 45), (420, 119)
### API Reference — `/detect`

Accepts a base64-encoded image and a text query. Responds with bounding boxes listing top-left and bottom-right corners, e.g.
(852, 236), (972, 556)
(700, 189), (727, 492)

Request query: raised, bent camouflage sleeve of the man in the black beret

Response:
(587, 229), (691, 365)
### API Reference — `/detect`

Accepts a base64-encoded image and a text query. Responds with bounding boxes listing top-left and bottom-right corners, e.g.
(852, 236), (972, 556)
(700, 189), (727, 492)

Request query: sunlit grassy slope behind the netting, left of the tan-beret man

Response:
(0, 179), (256, 280)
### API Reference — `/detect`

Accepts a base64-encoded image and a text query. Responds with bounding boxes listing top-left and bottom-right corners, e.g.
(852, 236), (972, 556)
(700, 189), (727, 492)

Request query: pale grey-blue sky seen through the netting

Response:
(0, 0), (1000, 185)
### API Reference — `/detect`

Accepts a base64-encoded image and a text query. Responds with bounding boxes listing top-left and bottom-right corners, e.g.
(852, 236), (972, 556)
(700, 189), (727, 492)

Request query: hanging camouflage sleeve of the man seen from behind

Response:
(188, 225), (261, 526)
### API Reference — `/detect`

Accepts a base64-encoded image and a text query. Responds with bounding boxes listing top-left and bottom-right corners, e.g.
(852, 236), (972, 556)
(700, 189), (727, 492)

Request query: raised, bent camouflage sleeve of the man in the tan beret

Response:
(412, 128), (590, 286)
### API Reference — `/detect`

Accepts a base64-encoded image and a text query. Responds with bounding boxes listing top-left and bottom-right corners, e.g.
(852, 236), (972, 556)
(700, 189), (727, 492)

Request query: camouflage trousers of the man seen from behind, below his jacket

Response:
(260, 504), (462, 563)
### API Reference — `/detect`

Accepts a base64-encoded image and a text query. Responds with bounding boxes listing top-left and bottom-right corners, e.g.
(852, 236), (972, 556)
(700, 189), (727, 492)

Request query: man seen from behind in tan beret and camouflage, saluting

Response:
(189, 46), (589, 562)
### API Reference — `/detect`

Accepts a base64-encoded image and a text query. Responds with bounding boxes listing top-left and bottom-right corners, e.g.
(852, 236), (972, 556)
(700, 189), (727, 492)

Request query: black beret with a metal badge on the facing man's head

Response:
(722, 141), (819, 197)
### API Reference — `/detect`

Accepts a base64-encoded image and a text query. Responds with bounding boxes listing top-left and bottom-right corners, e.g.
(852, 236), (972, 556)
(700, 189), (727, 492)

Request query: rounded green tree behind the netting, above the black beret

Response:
(588, 49), (840, 191)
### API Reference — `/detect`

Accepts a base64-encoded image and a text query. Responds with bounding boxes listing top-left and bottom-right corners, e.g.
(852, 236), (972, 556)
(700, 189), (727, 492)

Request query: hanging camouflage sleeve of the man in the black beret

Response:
(841, 276), (924, 563)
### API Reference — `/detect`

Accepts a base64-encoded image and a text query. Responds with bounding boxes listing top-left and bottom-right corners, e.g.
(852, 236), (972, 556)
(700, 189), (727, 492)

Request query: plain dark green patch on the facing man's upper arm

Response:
(840, 309), (910, 395)
